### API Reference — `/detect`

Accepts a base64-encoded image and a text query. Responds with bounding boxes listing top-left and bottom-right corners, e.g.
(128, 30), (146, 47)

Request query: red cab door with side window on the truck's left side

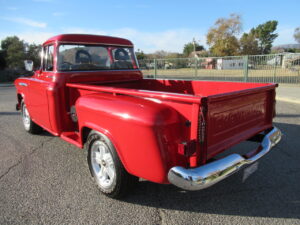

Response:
(26, 45), (54, 130)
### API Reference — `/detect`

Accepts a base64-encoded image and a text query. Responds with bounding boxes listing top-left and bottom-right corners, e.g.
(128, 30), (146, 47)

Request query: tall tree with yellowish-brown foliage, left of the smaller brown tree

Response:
(206, 14), (242, 56)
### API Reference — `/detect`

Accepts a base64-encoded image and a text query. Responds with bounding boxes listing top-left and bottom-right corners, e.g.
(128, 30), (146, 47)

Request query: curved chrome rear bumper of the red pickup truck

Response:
(168, 127), (282, 191)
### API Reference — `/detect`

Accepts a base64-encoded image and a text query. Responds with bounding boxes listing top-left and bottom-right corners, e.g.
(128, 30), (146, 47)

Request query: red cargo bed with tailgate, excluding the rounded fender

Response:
(67, 79), (277, 164)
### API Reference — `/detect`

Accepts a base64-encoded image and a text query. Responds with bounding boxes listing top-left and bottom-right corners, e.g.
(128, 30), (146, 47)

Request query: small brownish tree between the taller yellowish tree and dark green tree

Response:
(240, 33), (260, 55)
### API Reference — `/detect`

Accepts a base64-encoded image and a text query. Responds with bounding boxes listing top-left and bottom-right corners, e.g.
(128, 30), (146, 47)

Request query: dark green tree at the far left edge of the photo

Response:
(1, 36), (25, 69)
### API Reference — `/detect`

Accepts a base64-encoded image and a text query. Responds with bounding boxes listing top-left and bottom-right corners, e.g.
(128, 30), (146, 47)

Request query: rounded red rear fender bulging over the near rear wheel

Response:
(75, 93), (184, 183)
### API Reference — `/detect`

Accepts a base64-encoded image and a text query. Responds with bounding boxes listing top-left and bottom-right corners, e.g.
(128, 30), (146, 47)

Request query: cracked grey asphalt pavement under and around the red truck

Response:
(0, 87), (300, 225)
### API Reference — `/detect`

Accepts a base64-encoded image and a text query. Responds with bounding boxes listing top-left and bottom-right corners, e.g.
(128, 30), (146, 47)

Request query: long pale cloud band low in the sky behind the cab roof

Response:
(0, 27), (206, 53)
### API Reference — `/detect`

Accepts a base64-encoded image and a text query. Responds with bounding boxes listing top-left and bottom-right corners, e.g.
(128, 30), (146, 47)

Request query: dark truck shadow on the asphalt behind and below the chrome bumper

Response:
(125, 123), (300, 219)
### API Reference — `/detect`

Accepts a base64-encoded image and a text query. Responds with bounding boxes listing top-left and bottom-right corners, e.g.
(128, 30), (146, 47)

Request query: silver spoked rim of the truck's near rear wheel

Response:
(91, 141), (116, 188)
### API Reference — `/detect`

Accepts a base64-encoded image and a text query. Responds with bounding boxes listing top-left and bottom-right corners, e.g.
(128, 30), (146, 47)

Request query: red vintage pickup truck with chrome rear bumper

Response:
(15, 34), (281, 198)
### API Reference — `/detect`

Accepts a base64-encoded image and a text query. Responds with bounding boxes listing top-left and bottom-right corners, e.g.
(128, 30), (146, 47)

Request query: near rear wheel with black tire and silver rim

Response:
(87, 131), (138, 198)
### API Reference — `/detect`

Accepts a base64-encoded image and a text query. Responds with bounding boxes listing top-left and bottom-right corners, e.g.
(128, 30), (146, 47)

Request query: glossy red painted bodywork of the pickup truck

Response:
(15, 35), (276, 183)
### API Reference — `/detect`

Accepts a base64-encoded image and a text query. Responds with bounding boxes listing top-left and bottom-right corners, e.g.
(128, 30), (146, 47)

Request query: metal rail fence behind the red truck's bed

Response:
(139, 53), (300, 83)
